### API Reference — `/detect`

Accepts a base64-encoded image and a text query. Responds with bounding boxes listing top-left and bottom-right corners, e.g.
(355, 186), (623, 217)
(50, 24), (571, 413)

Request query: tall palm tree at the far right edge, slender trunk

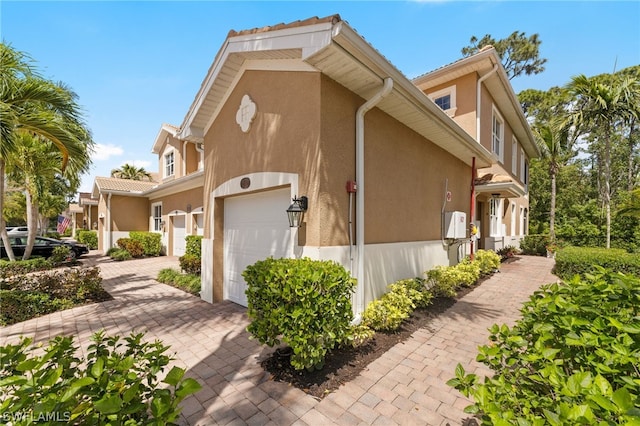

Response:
(567, 75), (640, 248)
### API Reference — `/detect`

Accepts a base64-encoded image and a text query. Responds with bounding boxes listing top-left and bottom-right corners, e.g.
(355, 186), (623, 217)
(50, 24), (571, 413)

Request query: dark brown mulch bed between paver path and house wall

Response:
(261, 258), (517, 399)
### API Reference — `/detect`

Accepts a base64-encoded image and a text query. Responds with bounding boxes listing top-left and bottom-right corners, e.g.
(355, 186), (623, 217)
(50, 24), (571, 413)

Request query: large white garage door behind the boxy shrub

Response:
(224, 188), (293, 306)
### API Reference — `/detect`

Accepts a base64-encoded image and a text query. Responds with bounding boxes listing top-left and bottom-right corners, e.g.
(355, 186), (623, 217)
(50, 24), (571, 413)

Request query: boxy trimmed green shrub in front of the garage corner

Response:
(242, 258), (355, 370)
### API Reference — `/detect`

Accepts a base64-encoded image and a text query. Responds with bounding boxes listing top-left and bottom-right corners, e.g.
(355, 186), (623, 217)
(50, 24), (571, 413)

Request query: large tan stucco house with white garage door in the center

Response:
(170, 15), (537, 313)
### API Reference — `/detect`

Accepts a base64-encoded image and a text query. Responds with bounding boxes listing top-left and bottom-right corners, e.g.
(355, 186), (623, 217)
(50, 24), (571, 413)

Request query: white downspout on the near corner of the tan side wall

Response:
(356, 77), (393, 316)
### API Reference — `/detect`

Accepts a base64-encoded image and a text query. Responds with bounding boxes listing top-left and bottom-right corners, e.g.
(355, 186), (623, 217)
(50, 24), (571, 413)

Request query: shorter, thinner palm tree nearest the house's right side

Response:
(533, 118), (575, 242)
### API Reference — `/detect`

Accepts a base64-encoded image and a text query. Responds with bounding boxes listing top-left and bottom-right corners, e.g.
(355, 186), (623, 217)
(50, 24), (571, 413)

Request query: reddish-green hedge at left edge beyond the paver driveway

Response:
(0, 267), (109, 325)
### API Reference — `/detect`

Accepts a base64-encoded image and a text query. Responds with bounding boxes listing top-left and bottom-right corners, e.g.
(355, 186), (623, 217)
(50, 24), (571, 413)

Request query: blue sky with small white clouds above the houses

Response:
(0, 0), (640, 195)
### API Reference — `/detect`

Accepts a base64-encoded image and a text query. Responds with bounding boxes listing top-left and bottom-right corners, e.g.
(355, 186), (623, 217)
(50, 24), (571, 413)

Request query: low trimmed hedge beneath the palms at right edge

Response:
(555, 247), (640, 279)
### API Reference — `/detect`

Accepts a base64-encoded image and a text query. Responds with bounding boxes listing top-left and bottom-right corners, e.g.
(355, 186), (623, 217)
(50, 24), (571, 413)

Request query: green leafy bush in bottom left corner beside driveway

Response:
(0, 332), (201, 425)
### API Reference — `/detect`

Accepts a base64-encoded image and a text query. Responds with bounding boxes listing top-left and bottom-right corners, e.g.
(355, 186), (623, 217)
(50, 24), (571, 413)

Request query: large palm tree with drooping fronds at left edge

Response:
(0, 43), (93, 260)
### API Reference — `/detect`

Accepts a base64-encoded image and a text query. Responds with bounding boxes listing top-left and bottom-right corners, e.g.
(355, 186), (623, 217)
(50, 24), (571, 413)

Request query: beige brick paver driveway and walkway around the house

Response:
(0, 251), (557, 426)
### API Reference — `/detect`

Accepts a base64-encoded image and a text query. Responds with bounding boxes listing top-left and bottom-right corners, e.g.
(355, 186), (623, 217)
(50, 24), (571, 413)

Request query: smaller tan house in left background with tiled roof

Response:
(91, 124), (204, 256)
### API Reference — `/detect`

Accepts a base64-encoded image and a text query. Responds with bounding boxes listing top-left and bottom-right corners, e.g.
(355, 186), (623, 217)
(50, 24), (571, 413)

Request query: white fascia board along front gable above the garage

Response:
(179, 22), (333, 139)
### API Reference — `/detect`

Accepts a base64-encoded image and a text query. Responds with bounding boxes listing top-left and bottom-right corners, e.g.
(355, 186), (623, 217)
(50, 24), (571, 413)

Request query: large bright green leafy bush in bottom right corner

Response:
(448, 267), (640, 425)
